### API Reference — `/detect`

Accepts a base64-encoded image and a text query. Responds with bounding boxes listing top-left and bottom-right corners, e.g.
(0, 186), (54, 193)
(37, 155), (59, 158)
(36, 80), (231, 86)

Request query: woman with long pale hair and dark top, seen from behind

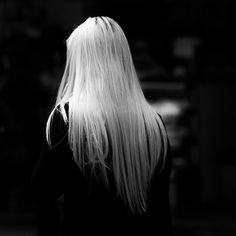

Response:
(33, 17), (171, 236)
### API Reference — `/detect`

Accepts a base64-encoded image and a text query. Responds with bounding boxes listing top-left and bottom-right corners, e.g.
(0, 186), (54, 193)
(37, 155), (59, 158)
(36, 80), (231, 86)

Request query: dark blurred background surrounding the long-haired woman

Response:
(0, 0), (236, 236)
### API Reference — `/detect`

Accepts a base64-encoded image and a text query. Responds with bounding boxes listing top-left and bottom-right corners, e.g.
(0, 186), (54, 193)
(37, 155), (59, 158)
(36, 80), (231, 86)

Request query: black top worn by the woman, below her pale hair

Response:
(32, 105), (172, 236)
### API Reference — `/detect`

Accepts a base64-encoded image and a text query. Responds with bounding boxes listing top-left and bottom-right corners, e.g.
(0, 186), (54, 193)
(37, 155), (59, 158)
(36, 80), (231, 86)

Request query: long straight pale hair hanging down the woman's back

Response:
(46, 17), (167, 213)
